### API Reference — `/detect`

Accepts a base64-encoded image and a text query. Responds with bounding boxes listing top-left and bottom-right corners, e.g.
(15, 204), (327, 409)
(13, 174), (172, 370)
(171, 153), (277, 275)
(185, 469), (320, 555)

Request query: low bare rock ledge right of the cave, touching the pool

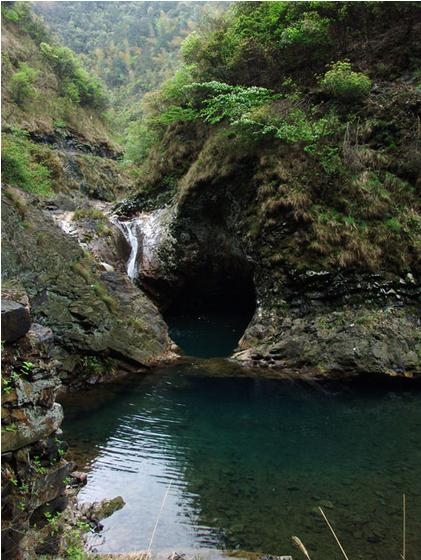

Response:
(235, 275), (421, 377)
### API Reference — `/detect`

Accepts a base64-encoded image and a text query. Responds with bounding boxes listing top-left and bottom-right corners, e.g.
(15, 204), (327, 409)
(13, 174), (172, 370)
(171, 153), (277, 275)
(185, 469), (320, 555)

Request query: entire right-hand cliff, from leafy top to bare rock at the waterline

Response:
(115, 3), (421, 376)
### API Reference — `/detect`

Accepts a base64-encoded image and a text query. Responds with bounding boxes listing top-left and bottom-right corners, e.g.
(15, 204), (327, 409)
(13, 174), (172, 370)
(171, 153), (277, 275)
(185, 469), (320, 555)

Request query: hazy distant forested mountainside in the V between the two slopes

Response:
(33, 1), (229, 143)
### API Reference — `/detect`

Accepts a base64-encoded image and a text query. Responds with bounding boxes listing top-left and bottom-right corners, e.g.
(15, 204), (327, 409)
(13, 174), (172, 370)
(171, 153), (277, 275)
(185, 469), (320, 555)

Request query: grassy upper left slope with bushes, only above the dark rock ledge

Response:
(2, 2), (109, 147)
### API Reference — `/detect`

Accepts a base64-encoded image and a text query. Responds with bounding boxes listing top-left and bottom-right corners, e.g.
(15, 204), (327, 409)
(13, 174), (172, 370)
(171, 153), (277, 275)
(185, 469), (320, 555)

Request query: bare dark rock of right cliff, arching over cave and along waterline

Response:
(119, 147), (421, 377)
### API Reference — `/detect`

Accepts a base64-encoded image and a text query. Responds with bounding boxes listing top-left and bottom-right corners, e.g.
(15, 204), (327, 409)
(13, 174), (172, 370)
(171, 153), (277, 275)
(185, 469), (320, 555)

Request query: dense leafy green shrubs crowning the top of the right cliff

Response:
(182, 2), (334, 87)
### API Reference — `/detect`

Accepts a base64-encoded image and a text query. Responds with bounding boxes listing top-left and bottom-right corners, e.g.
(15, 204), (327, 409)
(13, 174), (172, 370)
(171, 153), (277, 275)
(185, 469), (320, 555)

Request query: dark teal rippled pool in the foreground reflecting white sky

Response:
(63, 366), (421, 560)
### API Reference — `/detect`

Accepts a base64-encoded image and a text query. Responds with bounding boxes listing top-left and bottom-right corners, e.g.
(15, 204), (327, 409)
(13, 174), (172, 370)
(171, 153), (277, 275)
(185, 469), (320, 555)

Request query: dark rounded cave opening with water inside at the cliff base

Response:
(164, 265), (256, 358)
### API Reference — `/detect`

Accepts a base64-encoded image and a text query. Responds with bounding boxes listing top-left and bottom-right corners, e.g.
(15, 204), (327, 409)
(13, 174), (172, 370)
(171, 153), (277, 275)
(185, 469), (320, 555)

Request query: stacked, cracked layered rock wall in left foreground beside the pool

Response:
(2, 288), (73, 559)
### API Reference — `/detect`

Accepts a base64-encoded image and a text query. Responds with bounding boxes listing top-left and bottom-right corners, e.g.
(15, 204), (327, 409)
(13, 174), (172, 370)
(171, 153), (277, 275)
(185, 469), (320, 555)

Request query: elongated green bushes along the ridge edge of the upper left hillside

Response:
(40, 43), (106, 109)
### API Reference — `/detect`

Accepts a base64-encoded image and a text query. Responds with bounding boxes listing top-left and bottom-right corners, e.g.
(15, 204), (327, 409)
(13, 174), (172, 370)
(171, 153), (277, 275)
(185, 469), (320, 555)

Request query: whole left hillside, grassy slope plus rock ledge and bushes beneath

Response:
(1, 2), (130, 200)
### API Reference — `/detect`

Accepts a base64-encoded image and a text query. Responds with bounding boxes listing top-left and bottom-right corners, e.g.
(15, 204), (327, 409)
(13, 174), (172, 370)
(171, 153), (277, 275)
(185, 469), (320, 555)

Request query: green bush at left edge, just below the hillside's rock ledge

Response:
(1, 132), (52, 196)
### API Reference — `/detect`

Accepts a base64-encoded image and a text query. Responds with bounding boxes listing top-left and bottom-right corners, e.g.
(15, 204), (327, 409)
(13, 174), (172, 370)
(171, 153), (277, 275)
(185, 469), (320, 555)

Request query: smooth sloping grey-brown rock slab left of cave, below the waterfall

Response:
(3, 188), (170, 382)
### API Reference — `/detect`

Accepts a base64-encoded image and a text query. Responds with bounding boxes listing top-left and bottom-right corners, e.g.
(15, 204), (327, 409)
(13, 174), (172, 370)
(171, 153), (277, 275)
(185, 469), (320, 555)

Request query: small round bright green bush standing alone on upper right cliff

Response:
(320, 60), (372, 101)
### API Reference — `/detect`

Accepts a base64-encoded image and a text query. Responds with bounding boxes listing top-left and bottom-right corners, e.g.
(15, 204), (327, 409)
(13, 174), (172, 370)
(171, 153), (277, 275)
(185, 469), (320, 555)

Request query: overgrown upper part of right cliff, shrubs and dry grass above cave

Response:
(130, 2), (421, 274)
